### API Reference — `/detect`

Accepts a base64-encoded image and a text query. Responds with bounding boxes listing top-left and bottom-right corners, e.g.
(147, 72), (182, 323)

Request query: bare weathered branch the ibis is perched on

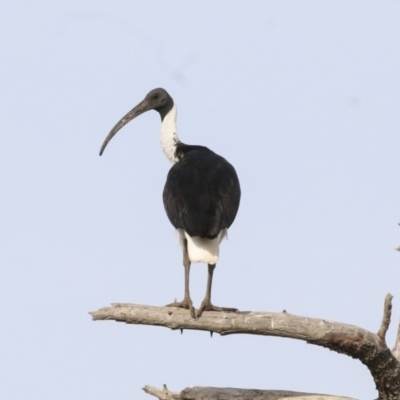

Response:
(90, 294), (400, 400)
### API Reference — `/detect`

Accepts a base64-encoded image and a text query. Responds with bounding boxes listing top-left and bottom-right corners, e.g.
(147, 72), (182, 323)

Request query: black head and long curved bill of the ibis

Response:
(100, 88), (174, 155)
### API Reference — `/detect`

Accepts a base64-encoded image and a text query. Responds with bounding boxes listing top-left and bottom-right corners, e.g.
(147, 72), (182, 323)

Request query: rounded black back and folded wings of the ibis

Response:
(163, 146), (240, 239)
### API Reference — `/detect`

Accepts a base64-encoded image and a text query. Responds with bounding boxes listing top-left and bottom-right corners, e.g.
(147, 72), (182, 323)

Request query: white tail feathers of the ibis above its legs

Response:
(178, 229), (227, 264)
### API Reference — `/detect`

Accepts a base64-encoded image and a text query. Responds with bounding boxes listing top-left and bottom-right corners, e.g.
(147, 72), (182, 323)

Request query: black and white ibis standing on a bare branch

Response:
(100, 88), (240, 318)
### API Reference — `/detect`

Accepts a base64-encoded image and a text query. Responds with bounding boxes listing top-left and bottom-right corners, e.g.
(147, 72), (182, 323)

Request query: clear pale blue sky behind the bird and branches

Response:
(0, 0), (400, 400)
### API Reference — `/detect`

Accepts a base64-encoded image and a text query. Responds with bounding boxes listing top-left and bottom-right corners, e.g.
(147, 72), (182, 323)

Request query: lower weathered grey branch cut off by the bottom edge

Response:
(143, 385), (354, 400)
